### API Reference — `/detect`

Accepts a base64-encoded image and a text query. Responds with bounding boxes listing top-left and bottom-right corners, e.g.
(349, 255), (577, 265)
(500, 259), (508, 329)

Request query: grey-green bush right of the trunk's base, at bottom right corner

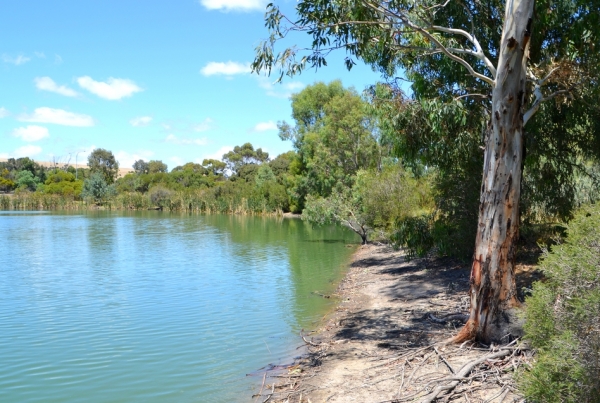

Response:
(519, 205), (600, 403)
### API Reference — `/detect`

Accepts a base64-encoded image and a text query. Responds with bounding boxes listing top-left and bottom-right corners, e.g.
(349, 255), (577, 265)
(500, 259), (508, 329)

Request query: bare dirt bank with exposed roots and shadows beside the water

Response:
(253, 245), (539, 403)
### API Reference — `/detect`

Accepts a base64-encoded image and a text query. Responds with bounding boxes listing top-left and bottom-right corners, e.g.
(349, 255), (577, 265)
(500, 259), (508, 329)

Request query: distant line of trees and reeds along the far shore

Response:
(0, 143), (295, 214)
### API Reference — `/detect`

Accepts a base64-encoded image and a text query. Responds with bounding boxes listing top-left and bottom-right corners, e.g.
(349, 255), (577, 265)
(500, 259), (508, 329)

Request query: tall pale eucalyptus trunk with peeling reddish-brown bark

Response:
(455, 0), (534, 343)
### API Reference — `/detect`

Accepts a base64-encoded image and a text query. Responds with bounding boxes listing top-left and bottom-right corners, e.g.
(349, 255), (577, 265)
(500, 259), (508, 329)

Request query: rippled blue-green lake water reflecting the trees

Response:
(0, 212), (359, 402)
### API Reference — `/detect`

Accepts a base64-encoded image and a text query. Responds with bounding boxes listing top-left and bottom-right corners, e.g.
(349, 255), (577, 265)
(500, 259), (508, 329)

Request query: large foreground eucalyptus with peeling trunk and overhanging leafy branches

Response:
(253, 0), (600, 342)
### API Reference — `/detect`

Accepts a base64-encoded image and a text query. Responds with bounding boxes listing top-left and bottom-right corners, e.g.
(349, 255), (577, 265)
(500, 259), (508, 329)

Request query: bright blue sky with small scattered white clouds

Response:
(0, 0), (380, 169)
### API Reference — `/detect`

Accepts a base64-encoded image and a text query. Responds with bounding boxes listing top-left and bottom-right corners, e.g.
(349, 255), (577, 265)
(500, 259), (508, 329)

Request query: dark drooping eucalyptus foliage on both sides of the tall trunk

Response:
(252, 0), (600, 257)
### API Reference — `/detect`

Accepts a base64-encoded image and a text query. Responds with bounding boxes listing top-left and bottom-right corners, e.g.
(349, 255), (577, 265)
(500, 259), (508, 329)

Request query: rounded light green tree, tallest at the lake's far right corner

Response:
(279, 81), (382, 209)
